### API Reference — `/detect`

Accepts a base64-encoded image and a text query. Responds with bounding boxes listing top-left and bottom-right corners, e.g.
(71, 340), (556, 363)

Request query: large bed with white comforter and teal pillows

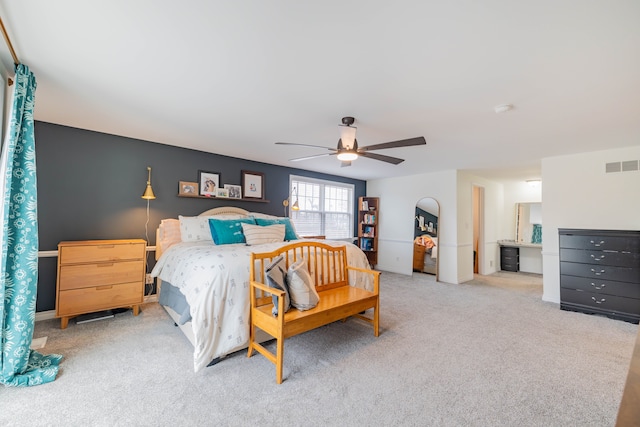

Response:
(151, 207), (373, 372)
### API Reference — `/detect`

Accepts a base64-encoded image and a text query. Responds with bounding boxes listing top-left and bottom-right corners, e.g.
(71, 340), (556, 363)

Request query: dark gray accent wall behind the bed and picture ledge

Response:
(35, 121), (366, 311)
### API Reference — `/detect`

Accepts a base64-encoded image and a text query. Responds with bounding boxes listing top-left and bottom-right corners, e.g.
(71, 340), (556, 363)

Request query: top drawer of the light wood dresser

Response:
(59, 243), (146, 264)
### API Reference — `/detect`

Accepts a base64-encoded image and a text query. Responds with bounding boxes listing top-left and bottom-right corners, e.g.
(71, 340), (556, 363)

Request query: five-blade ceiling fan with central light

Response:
(276, 117), (427, 167)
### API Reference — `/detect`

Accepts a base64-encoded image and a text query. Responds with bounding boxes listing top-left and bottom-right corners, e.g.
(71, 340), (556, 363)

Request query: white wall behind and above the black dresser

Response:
(542, 146), (640, 303)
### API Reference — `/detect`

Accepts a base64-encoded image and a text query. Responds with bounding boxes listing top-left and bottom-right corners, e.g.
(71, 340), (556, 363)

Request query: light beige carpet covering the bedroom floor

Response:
(0, 272), (638, 426)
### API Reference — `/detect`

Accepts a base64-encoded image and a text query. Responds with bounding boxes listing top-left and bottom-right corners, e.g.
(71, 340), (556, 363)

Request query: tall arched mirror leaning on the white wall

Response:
(413, 197), (440, 280)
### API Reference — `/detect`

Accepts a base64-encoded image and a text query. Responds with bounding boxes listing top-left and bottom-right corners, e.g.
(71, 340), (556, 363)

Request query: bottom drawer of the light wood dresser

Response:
(57, 281), (143, 316)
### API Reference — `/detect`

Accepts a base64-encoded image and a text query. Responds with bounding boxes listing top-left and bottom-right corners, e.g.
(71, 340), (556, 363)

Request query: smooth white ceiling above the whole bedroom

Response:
(0, 0), (640, 180)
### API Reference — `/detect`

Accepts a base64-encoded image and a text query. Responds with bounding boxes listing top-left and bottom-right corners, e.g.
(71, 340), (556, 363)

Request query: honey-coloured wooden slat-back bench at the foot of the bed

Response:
(247, 242), (380, 384)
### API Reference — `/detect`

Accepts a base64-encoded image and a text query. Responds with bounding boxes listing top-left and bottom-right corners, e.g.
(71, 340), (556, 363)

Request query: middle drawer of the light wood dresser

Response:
(59, 261), (144, 291)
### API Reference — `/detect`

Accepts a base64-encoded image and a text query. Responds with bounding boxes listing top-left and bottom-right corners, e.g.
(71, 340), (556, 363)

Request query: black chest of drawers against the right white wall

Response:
(559, 228), (640, 323)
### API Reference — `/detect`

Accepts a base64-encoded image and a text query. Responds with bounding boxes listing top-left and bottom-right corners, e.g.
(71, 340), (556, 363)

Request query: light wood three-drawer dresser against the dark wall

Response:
(56, 239), (146, 329)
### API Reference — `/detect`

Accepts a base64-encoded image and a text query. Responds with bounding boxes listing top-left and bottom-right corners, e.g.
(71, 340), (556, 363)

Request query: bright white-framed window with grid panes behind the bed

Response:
(289, 175), (354, 239)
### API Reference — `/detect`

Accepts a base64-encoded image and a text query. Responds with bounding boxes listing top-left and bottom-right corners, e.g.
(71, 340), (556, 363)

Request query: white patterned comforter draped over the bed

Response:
(151, 240), (373, 372)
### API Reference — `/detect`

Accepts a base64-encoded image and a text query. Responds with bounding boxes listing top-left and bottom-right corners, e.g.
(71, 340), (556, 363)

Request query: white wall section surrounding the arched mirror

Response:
(367, 170), (503, 283)
